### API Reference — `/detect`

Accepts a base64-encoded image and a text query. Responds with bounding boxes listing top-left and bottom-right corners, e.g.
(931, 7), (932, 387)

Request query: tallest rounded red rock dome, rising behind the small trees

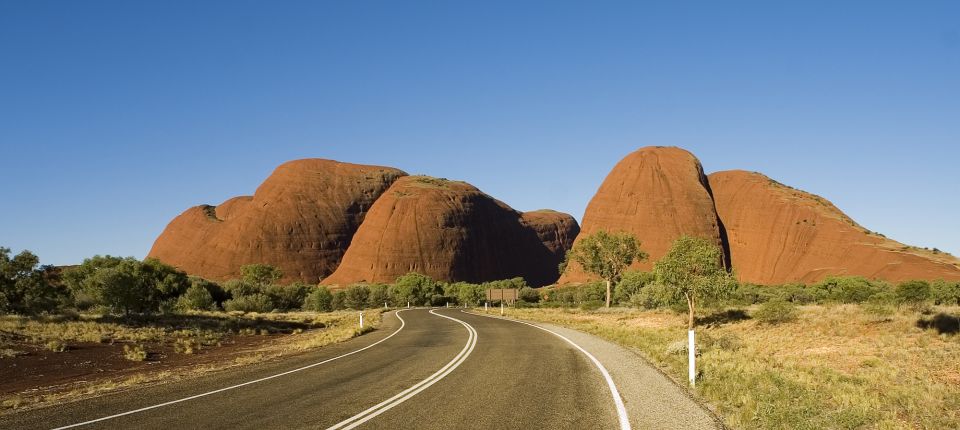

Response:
(560, 147), (723, 283)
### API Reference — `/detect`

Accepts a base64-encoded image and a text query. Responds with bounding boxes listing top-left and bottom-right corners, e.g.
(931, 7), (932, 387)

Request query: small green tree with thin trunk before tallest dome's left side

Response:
(561, 230), (647, 308)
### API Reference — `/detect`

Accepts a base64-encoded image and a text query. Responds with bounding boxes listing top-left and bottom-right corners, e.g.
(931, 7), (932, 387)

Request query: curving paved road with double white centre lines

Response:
(0, 309), (672, 430)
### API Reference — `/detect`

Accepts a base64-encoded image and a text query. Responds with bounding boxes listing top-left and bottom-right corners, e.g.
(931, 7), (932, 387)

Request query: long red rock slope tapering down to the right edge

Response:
(710, 170), (960, 284)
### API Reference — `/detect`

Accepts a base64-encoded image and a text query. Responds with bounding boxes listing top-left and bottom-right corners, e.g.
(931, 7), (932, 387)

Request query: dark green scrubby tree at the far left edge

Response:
(0, 247), (67, 315)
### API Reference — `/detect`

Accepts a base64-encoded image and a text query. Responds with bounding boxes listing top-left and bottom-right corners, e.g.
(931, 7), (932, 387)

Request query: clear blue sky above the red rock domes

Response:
(0, 0), (960, 264)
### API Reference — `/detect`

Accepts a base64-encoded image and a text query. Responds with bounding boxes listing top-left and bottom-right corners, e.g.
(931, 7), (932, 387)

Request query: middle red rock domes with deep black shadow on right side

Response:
(322, 176), (576, 286)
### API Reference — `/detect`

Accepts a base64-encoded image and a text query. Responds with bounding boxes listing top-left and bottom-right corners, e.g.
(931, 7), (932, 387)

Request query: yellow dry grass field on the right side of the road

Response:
(507, 305), (960, 429)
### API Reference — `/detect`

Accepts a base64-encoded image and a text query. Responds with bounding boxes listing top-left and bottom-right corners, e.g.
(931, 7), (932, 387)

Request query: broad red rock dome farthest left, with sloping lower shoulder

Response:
(148, 159), (406, 283)
